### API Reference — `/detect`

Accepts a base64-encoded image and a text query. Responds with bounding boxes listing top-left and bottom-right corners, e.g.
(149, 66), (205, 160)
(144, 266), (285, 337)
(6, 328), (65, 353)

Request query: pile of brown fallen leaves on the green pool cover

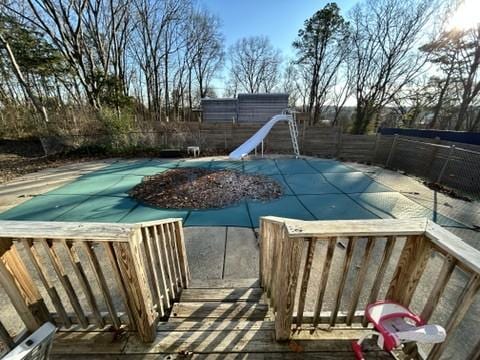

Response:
(129, 168), (282, 209)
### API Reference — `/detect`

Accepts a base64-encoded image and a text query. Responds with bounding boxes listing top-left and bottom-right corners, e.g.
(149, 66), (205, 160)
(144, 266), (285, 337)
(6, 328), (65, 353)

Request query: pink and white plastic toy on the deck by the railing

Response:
(352, 300), (446, 360)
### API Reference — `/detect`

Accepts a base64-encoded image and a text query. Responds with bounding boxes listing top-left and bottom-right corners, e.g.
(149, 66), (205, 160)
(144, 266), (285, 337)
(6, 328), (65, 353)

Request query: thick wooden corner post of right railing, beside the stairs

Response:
(275, 225), (304, 341)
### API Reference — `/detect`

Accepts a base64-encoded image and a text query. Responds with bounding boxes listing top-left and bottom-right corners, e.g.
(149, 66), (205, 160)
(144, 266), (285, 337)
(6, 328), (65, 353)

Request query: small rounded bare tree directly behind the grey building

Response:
(229, 36), (281, 93)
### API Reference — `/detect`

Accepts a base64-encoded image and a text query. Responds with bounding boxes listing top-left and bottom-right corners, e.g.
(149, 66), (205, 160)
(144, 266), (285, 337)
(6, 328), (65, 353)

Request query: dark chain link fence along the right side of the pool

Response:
(373, 135), (480, 200)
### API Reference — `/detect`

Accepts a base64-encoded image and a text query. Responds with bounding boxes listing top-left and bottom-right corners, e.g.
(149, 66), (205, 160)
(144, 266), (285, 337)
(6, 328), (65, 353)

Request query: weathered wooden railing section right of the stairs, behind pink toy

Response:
(260, 217), (480, 359)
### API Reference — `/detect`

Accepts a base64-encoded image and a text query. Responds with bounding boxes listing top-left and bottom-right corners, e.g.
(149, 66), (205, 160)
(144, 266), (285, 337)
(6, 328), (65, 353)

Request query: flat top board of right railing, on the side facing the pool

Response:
(263, 216), (427, 238)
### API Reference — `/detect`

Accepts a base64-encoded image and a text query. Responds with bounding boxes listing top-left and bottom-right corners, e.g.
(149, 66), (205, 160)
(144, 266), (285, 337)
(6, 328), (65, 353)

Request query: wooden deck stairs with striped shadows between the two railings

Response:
(134, 279), (391, 359)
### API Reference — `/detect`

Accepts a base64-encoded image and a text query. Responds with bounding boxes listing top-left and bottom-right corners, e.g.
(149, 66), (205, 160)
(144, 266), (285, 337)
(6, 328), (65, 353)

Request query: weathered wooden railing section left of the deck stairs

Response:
(0, 219), (190, 346)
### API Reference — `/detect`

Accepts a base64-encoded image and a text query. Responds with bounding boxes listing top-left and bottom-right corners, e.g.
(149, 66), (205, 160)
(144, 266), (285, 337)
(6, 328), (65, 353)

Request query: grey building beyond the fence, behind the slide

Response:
(201, 94), (288, 123)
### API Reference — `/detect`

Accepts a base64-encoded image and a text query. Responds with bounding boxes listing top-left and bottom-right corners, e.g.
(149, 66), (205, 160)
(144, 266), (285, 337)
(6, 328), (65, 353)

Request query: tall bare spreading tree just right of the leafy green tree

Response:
(350, 0), (435, 134)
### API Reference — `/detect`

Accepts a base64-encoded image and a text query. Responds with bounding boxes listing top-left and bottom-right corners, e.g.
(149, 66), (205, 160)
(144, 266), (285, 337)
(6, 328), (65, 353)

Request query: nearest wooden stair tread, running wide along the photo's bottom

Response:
(52, 329), (391, 360)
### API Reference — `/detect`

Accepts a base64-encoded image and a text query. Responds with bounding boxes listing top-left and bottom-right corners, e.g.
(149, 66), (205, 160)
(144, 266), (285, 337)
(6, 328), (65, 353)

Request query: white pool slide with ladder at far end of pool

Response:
(228, 114), (300, 160)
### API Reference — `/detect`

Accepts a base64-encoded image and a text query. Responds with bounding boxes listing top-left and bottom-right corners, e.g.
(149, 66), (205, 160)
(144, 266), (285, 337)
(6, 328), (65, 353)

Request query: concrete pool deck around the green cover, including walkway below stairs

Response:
(0, 157), (480, 279)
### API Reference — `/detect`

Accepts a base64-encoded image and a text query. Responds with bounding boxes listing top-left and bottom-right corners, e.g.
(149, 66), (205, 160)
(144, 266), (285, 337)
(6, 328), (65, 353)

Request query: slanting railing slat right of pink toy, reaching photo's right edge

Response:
(428, 274), (480, 360)
